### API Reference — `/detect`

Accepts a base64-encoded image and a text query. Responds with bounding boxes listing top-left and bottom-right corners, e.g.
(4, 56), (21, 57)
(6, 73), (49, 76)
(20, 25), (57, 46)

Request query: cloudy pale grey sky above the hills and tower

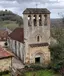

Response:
(0, 0), (64, 18)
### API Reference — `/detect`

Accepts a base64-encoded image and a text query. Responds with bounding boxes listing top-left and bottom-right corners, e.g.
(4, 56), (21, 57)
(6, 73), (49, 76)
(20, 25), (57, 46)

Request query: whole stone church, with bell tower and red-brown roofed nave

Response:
(8, 8), (50, 64)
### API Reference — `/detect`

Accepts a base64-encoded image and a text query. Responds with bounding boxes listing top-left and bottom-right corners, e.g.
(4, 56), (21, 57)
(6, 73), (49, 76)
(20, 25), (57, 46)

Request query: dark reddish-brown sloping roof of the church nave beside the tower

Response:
(9, 28), (24, 43)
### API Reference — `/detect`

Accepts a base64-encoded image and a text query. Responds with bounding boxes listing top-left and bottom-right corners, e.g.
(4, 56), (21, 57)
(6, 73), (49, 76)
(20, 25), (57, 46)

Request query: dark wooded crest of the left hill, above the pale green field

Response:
(0, 10), (23, 26)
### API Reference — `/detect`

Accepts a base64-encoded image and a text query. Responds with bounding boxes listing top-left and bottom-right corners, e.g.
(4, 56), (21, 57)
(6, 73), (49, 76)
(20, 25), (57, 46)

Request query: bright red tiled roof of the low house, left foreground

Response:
(0, 46), (13, 59)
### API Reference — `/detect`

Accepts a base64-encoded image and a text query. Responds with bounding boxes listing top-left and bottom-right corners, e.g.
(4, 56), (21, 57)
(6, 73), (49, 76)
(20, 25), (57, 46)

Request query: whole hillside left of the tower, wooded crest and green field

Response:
(0, 10), (23, 30)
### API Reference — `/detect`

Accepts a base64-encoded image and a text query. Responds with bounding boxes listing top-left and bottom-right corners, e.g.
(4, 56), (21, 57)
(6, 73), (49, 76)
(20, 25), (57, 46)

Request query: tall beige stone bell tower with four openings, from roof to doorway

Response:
(23, 8), (50, 64)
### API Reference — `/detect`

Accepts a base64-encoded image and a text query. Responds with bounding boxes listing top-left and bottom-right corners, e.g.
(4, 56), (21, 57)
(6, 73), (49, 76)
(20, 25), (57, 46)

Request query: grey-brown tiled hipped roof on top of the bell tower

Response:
(23, 8), (50, 14)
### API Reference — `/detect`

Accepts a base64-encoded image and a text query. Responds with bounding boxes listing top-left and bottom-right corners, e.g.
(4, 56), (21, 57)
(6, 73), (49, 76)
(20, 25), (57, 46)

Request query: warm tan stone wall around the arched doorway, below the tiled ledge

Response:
(26, 46), (50, 64)
